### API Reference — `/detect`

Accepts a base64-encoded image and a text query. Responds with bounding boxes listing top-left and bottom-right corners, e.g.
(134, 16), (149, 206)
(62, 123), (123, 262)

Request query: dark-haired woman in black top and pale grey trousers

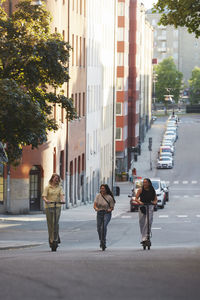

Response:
(135, 178), (157, 244)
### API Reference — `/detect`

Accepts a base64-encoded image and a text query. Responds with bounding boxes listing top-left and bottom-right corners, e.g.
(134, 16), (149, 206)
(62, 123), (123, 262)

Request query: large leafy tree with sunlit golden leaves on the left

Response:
(0, 0), (75, 163)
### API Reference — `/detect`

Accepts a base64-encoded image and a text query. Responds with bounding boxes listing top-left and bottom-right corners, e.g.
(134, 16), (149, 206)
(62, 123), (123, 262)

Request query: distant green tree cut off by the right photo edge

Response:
(188, 67), (200, 104)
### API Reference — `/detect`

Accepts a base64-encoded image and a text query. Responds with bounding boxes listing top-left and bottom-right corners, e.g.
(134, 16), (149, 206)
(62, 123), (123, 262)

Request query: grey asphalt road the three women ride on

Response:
(0, 116), (200, 300)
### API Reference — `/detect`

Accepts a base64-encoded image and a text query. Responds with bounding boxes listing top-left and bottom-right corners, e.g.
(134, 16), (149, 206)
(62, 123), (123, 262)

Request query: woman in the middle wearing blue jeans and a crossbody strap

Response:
(94, 184), (115, 248)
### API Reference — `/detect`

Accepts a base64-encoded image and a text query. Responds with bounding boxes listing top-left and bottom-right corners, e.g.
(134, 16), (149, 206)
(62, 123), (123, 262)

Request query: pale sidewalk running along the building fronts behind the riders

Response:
(0, 121), (165, 250)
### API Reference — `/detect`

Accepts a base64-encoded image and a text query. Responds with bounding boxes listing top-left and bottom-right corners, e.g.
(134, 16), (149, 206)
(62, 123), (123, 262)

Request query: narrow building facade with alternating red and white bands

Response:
(116, 0), (130, 173)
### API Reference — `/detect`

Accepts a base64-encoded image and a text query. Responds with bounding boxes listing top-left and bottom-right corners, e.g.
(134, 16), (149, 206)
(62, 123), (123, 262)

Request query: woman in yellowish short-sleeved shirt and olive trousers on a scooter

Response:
(42, 173), (64, 247)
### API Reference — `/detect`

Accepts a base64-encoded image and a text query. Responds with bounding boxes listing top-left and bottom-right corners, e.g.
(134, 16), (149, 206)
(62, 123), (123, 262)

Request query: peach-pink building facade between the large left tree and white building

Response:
(66, 0), (87, 207)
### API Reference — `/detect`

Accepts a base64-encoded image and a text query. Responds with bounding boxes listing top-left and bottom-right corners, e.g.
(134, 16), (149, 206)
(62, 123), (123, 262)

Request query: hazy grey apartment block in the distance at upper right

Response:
(146, 10), (200, 84)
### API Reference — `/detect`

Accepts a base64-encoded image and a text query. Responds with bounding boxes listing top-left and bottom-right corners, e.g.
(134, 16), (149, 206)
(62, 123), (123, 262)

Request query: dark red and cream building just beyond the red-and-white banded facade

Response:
(128, 0), (153, 169)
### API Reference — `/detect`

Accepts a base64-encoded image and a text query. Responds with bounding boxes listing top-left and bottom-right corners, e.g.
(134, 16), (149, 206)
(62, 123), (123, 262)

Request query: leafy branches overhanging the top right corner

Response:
(154, 0), (200, 38)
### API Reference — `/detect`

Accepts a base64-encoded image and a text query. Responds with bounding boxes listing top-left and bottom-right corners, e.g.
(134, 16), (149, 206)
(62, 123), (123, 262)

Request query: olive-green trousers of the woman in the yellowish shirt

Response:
(46, 207), (61, 243)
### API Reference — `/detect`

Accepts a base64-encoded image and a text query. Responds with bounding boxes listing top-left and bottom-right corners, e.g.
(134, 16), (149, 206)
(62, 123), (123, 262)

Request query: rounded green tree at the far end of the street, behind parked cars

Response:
(155, 57), (183, 103)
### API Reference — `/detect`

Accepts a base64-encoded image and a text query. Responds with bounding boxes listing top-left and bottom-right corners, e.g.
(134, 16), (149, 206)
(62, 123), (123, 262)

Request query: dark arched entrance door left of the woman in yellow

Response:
(29, 166), (41, 211)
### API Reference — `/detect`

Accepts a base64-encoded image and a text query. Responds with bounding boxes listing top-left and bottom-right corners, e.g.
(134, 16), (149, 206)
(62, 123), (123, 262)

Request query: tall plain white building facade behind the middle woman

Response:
(86, 0), (116, 201)
